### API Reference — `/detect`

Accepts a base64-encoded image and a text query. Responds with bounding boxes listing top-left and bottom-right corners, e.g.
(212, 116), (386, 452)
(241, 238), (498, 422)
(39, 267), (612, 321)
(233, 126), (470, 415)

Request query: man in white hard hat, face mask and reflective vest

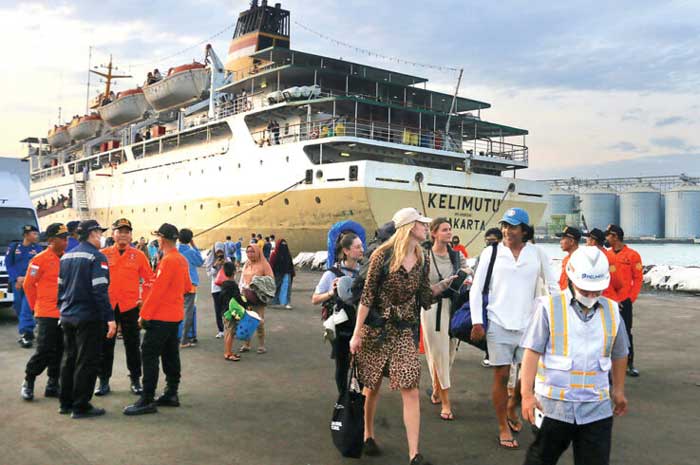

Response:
(521, 246), (628, 465)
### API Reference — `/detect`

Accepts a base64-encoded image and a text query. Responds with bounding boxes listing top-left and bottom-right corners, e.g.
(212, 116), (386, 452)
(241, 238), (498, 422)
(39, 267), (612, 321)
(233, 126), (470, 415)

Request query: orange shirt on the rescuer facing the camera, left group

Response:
(101, 244), (154, 313)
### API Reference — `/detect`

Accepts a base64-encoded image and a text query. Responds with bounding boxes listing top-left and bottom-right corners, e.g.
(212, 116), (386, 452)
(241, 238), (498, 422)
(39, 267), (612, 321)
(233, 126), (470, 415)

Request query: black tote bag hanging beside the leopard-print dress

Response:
(331, 357), (365, 459)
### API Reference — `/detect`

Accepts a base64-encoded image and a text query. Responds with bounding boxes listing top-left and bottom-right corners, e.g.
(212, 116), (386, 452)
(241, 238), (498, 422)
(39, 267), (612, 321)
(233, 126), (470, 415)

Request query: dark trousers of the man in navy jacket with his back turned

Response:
(60, 320), (106, 411)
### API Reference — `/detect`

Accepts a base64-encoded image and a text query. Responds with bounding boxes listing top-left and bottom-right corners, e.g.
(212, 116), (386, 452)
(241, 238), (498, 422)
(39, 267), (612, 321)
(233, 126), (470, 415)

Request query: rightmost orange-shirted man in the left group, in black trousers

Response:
(124, 223), (192, 415)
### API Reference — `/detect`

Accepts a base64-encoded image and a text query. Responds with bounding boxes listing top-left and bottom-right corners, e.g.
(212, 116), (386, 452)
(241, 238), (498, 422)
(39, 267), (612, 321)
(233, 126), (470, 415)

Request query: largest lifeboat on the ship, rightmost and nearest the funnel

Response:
(143, 62), (210, 111)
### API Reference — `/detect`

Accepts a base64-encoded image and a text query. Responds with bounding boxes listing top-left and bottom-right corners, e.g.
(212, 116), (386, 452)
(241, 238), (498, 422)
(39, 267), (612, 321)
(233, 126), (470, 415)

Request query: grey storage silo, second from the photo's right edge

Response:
(620, 184), (663, 238)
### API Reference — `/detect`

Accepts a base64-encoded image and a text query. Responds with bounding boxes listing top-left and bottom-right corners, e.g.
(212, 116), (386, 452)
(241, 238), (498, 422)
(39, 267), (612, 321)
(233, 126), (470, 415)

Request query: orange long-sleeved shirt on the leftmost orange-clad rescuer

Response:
(23, 247), (61, 318)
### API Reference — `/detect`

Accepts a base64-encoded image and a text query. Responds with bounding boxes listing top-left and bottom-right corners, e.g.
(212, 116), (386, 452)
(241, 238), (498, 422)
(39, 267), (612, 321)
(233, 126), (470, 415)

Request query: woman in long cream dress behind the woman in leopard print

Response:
(421, 218), (471, 421)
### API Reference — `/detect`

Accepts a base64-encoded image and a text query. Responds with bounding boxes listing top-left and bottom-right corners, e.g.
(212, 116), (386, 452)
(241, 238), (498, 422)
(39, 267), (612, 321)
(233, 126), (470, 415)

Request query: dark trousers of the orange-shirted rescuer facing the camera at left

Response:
(98, 305), (141, 379)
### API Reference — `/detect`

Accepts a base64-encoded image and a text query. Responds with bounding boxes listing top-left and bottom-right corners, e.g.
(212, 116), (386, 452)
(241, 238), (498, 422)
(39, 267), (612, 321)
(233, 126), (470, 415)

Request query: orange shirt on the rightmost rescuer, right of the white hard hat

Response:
(603, 245), (644, 302)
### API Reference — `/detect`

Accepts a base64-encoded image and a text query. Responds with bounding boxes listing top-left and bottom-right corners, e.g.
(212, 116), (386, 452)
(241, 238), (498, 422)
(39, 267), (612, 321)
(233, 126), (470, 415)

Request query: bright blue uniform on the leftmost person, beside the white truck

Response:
(5, 242), (44, 338)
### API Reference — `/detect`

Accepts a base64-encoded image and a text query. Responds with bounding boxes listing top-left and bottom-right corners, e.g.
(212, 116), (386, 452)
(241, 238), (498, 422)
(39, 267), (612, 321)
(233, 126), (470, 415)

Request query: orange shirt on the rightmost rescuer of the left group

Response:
(141, 249), (192, 322)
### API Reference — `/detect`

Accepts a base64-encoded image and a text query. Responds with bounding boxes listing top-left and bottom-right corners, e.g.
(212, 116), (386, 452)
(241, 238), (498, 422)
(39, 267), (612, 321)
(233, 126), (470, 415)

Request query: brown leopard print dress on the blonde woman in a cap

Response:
(357, 251), (433, 390)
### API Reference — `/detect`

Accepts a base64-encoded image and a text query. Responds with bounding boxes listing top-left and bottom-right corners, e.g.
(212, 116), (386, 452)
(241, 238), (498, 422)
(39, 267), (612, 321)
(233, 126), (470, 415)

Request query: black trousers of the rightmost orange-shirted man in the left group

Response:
(141, 320), (180, 400)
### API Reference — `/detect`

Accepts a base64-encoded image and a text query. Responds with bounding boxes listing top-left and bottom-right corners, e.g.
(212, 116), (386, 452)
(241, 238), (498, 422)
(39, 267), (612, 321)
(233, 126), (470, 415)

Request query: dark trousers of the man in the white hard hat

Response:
(524, 417), (612, 465)
